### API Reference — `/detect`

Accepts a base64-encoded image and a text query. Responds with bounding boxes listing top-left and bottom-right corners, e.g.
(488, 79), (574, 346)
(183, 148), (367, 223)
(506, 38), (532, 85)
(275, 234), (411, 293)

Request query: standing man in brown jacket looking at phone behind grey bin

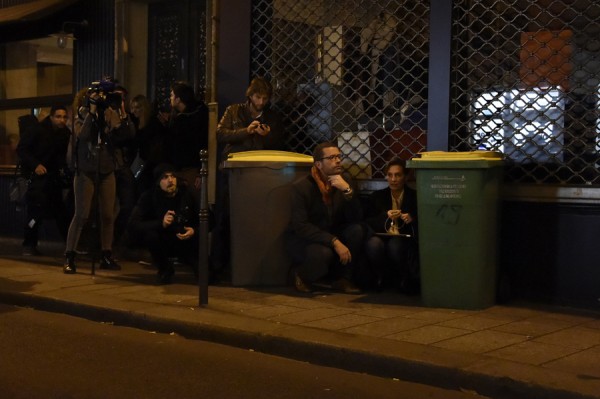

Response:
(211, 77), (286, 282)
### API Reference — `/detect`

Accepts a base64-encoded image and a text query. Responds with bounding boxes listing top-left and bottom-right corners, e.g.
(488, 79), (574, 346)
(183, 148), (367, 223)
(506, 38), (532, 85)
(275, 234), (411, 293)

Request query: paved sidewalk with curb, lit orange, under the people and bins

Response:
(0, 238), (600, 399)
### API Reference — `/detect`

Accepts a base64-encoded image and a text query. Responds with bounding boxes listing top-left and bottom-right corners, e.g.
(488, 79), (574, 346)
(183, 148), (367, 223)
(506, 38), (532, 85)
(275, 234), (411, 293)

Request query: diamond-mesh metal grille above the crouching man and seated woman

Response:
(251, 0), (429, 179)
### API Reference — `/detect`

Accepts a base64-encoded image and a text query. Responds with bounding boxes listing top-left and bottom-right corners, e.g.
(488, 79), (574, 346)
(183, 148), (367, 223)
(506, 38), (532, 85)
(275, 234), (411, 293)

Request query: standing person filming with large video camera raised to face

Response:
(63, 80), (135, 274)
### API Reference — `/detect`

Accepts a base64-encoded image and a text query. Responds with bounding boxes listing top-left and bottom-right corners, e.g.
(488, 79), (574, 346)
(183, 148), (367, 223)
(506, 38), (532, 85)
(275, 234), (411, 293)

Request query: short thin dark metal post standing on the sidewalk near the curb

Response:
(198, 150), (209, 306)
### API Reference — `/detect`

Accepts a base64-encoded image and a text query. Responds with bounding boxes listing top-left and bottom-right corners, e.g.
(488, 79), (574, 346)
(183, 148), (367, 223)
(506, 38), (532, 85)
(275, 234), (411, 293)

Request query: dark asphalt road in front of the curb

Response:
(0, 304), (492, 399)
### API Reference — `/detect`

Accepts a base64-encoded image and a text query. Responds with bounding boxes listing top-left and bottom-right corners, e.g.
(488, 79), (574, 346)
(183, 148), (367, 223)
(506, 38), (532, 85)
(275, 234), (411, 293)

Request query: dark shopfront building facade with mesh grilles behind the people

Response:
(0, 0), (600, 307)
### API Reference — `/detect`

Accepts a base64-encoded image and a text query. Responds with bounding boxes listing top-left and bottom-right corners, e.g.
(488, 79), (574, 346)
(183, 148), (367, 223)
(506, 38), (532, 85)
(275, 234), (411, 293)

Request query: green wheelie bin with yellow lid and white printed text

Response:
(407, 151), (504, 309)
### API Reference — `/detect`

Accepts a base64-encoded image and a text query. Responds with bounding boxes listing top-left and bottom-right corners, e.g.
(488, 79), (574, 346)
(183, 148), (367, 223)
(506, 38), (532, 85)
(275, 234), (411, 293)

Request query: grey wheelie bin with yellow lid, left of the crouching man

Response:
(224, 150), (313, 286)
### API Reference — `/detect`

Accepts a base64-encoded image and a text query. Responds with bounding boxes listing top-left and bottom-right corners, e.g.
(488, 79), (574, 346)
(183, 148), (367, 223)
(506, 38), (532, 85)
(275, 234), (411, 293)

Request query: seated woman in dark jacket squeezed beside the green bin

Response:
(365, 158), (419, 293)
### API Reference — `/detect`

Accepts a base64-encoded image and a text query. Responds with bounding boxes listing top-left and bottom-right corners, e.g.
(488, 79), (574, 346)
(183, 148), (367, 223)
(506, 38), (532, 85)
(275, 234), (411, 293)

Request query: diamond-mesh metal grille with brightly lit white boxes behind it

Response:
(449, 0), (600, 184)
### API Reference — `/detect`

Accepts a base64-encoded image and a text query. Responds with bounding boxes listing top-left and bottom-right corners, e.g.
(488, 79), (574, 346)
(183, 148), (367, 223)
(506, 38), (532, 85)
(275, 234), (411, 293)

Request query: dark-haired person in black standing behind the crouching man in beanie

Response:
(166, 82), (208, 197)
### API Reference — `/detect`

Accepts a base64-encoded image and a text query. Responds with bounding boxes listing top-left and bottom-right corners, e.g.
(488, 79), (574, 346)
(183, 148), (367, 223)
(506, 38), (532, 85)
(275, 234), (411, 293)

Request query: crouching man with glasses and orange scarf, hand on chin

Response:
(287, 142), (366, 294)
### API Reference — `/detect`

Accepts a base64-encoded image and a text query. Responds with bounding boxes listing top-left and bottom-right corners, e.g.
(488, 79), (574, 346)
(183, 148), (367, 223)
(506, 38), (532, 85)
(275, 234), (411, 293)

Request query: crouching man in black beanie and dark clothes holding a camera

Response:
(129, 163), (199, 284)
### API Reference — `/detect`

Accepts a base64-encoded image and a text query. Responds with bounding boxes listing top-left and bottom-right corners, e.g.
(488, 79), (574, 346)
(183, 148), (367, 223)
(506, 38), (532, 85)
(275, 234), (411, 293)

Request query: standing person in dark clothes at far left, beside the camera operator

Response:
(17, 105), (71, 256)
